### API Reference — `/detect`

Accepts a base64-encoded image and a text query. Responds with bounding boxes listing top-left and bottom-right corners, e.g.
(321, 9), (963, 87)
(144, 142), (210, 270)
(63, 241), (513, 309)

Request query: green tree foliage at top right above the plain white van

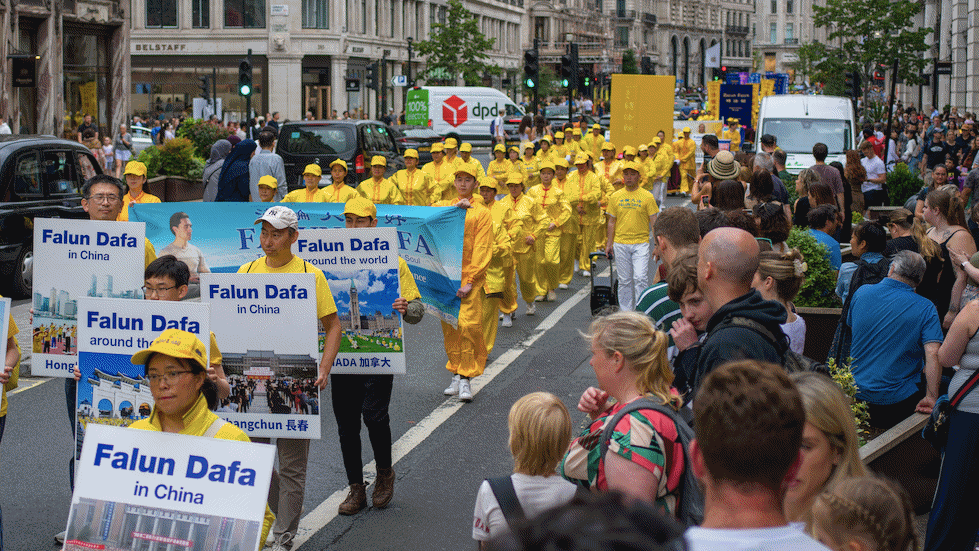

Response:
(812, 0), (932, 103)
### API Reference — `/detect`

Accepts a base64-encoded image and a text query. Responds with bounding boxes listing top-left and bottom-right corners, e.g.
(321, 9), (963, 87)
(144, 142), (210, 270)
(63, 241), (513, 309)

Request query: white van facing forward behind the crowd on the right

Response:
(756, 94), (858, 174)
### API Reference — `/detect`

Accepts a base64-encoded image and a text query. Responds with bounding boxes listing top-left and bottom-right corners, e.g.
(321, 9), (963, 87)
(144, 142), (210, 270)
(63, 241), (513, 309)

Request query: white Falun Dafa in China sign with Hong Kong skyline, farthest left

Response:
(31, 218), (146, 377)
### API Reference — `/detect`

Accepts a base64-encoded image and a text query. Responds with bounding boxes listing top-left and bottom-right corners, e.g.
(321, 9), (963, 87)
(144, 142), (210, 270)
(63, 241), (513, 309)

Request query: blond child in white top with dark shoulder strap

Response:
(473, 392), (576, 549)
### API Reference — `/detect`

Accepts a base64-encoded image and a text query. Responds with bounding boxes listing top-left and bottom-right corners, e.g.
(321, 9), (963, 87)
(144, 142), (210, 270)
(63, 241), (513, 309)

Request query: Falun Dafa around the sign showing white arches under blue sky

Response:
(75, 298), (212, 448)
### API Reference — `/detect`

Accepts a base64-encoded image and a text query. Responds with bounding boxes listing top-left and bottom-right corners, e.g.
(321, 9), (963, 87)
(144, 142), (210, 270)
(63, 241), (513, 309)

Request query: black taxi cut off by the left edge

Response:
(0, 135), (102, 297)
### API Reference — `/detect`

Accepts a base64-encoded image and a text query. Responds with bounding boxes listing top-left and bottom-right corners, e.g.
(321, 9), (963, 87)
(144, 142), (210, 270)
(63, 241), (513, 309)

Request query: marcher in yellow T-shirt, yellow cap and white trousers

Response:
(605, 161), (659, 310)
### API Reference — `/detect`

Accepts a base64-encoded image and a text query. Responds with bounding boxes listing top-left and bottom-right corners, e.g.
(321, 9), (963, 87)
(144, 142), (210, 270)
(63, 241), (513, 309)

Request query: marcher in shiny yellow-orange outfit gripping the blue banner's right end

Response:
(432, 165), (493, 402)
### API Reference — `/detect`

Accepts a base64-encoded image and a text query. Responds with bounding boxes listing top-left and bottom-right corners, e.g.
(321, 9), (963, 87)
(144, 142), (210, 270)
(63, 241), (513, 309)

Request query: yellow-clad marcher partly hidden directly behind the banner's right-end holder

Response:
(479, 176), (513, 354)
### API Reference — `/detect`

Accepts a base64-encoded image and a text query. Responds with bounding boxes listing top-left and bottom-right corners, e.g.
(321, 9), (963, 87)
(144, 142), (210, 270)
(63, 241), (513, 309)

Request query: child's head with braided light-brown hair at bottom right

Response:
(809, 476), (918, 551)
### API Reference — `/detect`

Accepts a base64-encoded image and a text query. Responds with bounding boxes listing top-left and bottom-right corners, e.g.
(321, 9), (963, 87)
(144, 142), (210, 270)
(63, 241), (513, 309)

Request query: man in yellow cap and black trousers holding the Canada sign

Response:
(330, 197), (425, 515)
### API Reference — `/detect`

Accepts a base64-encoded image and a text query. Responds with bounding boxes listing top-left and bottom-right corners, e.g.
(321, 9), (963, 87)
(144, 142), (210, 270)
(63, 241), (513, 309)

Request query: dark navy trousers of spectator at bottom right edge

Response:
(925, 411), (979, 551)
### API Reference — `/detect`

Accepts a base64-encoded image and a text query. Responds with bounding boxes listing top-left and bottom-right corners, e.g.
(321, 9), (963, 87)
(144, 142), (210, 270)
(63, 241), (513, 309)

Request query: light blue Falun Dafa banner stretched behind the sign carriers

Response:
(129, 203), (466, 324)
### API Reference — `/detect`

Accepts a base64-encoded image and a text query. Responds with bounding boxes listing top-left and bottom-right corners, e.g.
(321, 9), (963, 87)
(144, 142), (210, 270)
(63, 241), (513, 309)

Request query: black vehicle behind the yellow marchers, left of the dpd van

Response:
(275, 120), (405, 190)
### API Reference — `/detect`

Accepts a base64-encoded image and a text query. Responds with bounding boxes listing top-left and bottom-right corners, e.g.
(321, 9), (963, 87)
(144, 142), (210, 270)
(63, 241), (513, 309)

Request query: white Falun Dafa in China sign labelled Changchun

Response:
(201, 272), (320, 439)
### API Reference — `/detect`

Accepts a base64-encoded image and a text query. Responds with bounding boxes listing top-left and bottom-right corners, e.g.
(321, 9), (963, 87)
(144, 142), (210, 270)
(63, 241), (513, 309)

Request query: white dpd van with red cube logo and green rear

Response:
(405, 86), (523, 144)
